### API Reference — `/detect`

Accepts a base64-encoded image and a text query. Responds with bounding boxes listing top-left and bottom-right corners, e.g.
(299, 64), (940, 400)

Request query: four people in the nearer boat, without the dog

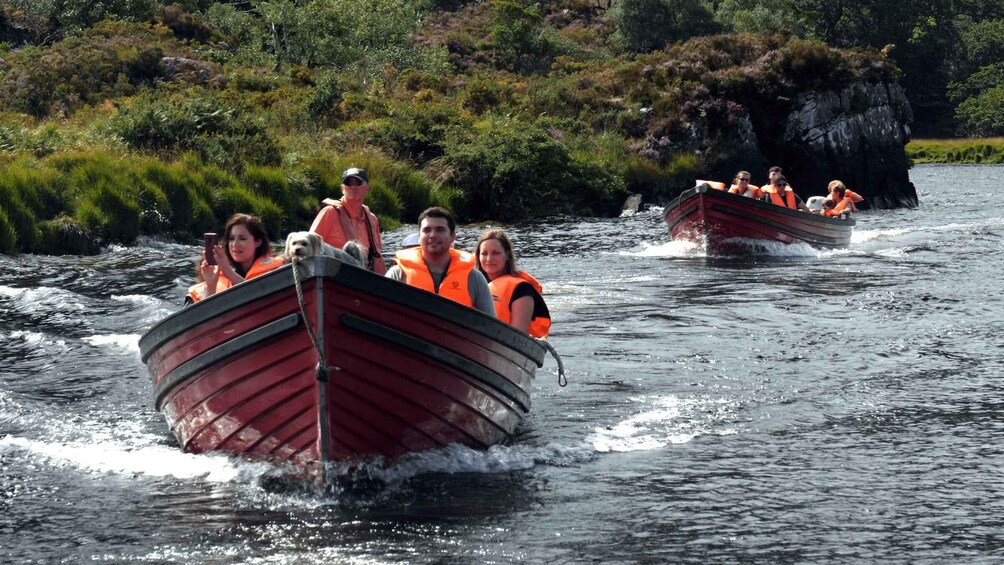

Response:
(185, 168), (551, 338)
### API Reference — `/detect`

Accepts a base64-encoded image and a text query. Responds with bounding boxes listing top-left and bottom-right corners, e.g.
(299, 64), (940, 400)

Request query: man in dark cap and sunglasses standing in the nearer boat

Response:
(310, 167), (387, 275)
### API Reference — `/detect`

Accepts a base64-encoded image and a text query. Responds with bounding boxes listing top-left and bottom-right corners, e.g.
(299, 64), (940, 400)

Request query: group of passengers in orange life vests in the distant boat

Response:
(697, 167), (864, 218)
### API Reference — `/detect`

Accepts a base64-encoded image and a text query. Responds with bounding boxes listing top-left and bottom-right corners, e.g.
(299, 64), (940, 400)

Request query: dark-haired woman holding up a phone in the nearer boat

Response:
(186, 214), (284, 304)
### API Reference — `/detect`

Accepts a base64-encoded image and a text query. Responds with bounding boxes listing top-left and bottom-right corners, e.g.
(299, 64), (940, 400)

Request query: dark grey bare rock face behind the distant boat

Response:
(712, 81), (918, 208)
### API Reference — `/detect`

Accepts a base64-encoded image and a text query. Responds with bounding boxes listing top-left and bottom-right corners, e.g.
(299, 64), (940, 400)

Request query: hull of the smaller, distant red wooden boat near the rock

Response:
(664, 184), (855, 255)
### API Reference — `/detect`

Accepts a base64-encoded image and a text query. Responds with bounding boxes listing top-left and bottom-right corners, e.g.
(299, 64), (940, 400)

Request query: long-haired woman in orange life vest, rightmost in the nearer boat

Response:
(474, 230), (551, 338)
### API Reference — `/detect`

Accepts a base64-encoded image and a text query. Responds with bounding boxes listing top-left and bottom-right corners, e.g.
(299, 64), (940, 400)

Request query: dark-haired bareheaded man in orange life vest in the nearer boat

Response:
(387, 207), (495, 317)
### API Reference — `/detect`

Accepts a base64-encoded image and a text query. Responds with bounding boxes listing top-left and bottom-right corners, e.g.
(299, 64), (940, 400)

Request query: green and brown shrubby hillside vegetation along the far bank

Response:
(0, 0), (1004, 253)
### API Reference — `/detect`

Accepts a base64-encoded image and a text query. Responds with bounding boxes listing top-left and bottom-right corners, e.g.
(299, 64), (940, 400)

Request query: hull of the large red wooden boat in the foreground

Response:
(140, 257), (545, 482)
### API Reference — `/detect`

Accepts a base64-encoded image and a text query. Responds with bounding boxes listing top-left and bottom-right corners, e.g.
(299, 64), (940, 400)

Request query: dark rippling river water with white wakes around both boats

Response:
(0, 167), (1004, 564)
